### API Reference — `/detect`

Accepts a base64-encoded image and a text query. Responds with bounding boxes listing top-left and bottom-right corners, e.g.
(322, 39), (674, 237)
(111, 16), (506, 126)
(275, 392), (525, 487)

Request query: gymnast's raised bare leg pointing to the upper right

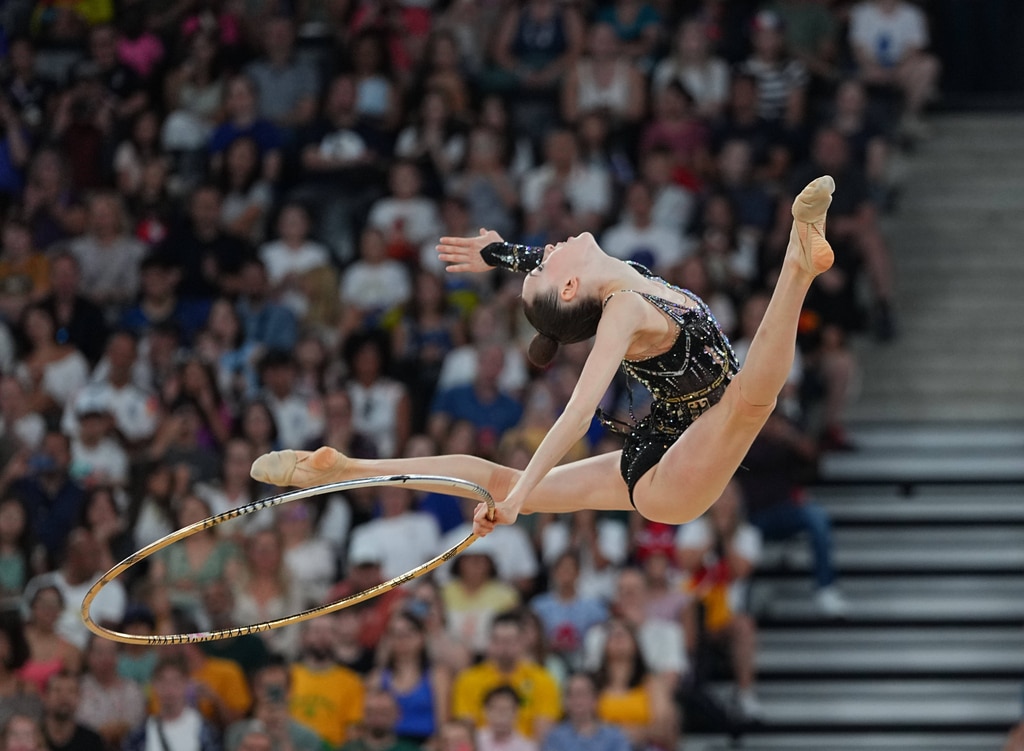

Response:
(634, 176), (836, 524)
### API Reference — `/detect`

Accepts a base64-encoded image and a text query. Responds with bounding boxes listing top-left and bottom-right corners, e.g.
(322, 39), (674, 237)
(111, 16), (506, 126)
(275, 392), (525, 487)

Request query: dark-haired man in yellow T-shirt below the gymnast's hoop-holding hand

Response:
(452, 613), (562, 740)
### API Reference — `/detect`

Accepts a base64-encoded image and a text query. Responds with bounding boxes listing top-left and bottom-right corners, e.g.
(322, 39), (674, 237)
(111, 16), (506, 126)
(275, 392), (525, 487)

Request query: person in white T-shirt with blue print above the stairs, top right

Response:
(849, 0), (941, 138)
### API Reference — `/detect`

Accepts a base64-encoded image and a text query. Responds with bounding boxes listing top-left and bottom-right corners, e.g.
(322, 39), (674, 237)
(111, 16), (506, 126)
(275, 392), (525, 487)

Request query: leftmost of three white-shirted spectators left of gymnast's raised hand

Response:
(259, 203), (331, 319)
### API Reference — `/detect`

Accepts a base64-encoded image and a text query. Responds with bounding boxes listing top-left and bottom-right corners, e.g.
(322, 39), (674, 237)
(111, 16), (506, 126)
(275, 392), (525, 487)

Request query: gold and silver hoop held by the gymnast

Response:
(82, 474), (495, 646)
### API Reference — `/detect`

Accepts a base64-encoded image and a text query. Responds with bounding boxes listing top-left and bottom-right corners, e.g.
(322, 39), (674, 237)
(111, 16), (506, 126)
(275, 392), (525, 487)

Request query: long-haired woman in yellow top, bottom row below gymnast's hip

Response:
(596, 619), (679, 748)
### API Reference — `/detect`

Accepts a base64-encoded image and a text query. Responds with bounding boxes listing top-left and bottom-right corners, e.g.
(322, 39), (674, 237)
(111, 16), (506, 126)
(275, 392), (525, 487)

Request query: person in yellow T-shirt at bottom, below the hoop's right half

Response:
(290, 616), (365, 748)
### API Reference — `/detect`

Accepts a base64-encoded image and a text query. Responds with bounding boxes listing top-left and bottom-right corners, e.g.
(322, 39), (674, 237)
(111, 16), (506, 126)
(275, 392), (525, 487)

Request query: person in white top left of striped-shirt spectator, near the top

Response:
(651, 17), (729, 121)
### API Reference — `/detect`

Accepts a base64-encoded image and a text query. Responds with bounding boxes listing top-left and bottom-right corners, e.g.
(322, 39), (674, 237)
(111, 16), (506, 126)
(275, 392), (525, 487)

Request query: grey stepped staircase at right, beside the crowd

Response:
(684, 115), (1024, 751)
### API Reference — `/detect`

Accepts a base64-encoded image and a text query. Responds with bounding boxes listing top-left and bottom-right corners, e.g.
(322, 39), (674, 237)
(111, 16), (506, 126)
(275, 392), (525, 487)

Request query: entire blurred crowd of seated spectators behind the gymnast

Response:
(0, 0), (939, 751)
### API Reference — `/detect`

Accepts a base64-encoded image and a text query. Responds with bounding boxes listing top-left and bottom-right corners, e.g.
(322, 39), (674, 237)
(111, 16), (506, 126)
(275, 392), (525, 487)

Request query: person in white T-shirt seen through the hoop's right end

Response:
(349, 479), (440, 579)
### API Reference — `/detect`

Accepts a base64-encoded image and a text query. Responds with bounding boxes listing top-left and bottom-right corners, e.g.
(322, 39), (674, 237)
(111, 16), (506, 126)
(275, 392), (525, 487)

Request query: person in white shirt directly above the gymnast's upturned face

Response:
(520, 130), (611, 226)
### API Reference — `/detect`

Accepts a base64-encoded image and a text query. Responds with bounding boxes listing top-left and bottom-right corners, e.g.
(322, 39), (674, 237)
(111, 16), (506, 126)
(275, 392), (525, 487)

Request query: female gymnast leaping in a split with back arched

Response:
(252, 175), (835, 536)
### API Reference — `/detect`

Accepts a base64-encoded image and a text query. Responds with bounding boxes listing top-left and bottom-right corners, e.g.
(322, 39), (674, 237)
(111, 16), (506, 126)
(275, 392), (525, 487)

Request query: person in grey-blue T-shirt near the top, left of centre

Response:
(245, 15), (318, 140)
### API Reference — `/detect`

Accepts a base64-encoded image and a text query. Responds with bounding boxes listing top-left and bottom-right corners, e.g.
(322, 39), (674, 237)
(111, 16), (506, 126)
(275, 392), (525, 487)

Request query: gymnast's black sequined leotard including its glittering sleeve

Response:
(481, 243), (739, 505)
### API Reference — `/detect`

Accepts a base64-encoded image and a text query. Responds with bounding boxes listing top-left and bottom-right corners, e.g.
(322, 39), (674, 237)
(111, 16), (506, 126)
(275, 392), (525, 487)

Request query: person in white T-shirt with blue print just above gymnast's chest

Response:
(601, 180), (688, 276)
